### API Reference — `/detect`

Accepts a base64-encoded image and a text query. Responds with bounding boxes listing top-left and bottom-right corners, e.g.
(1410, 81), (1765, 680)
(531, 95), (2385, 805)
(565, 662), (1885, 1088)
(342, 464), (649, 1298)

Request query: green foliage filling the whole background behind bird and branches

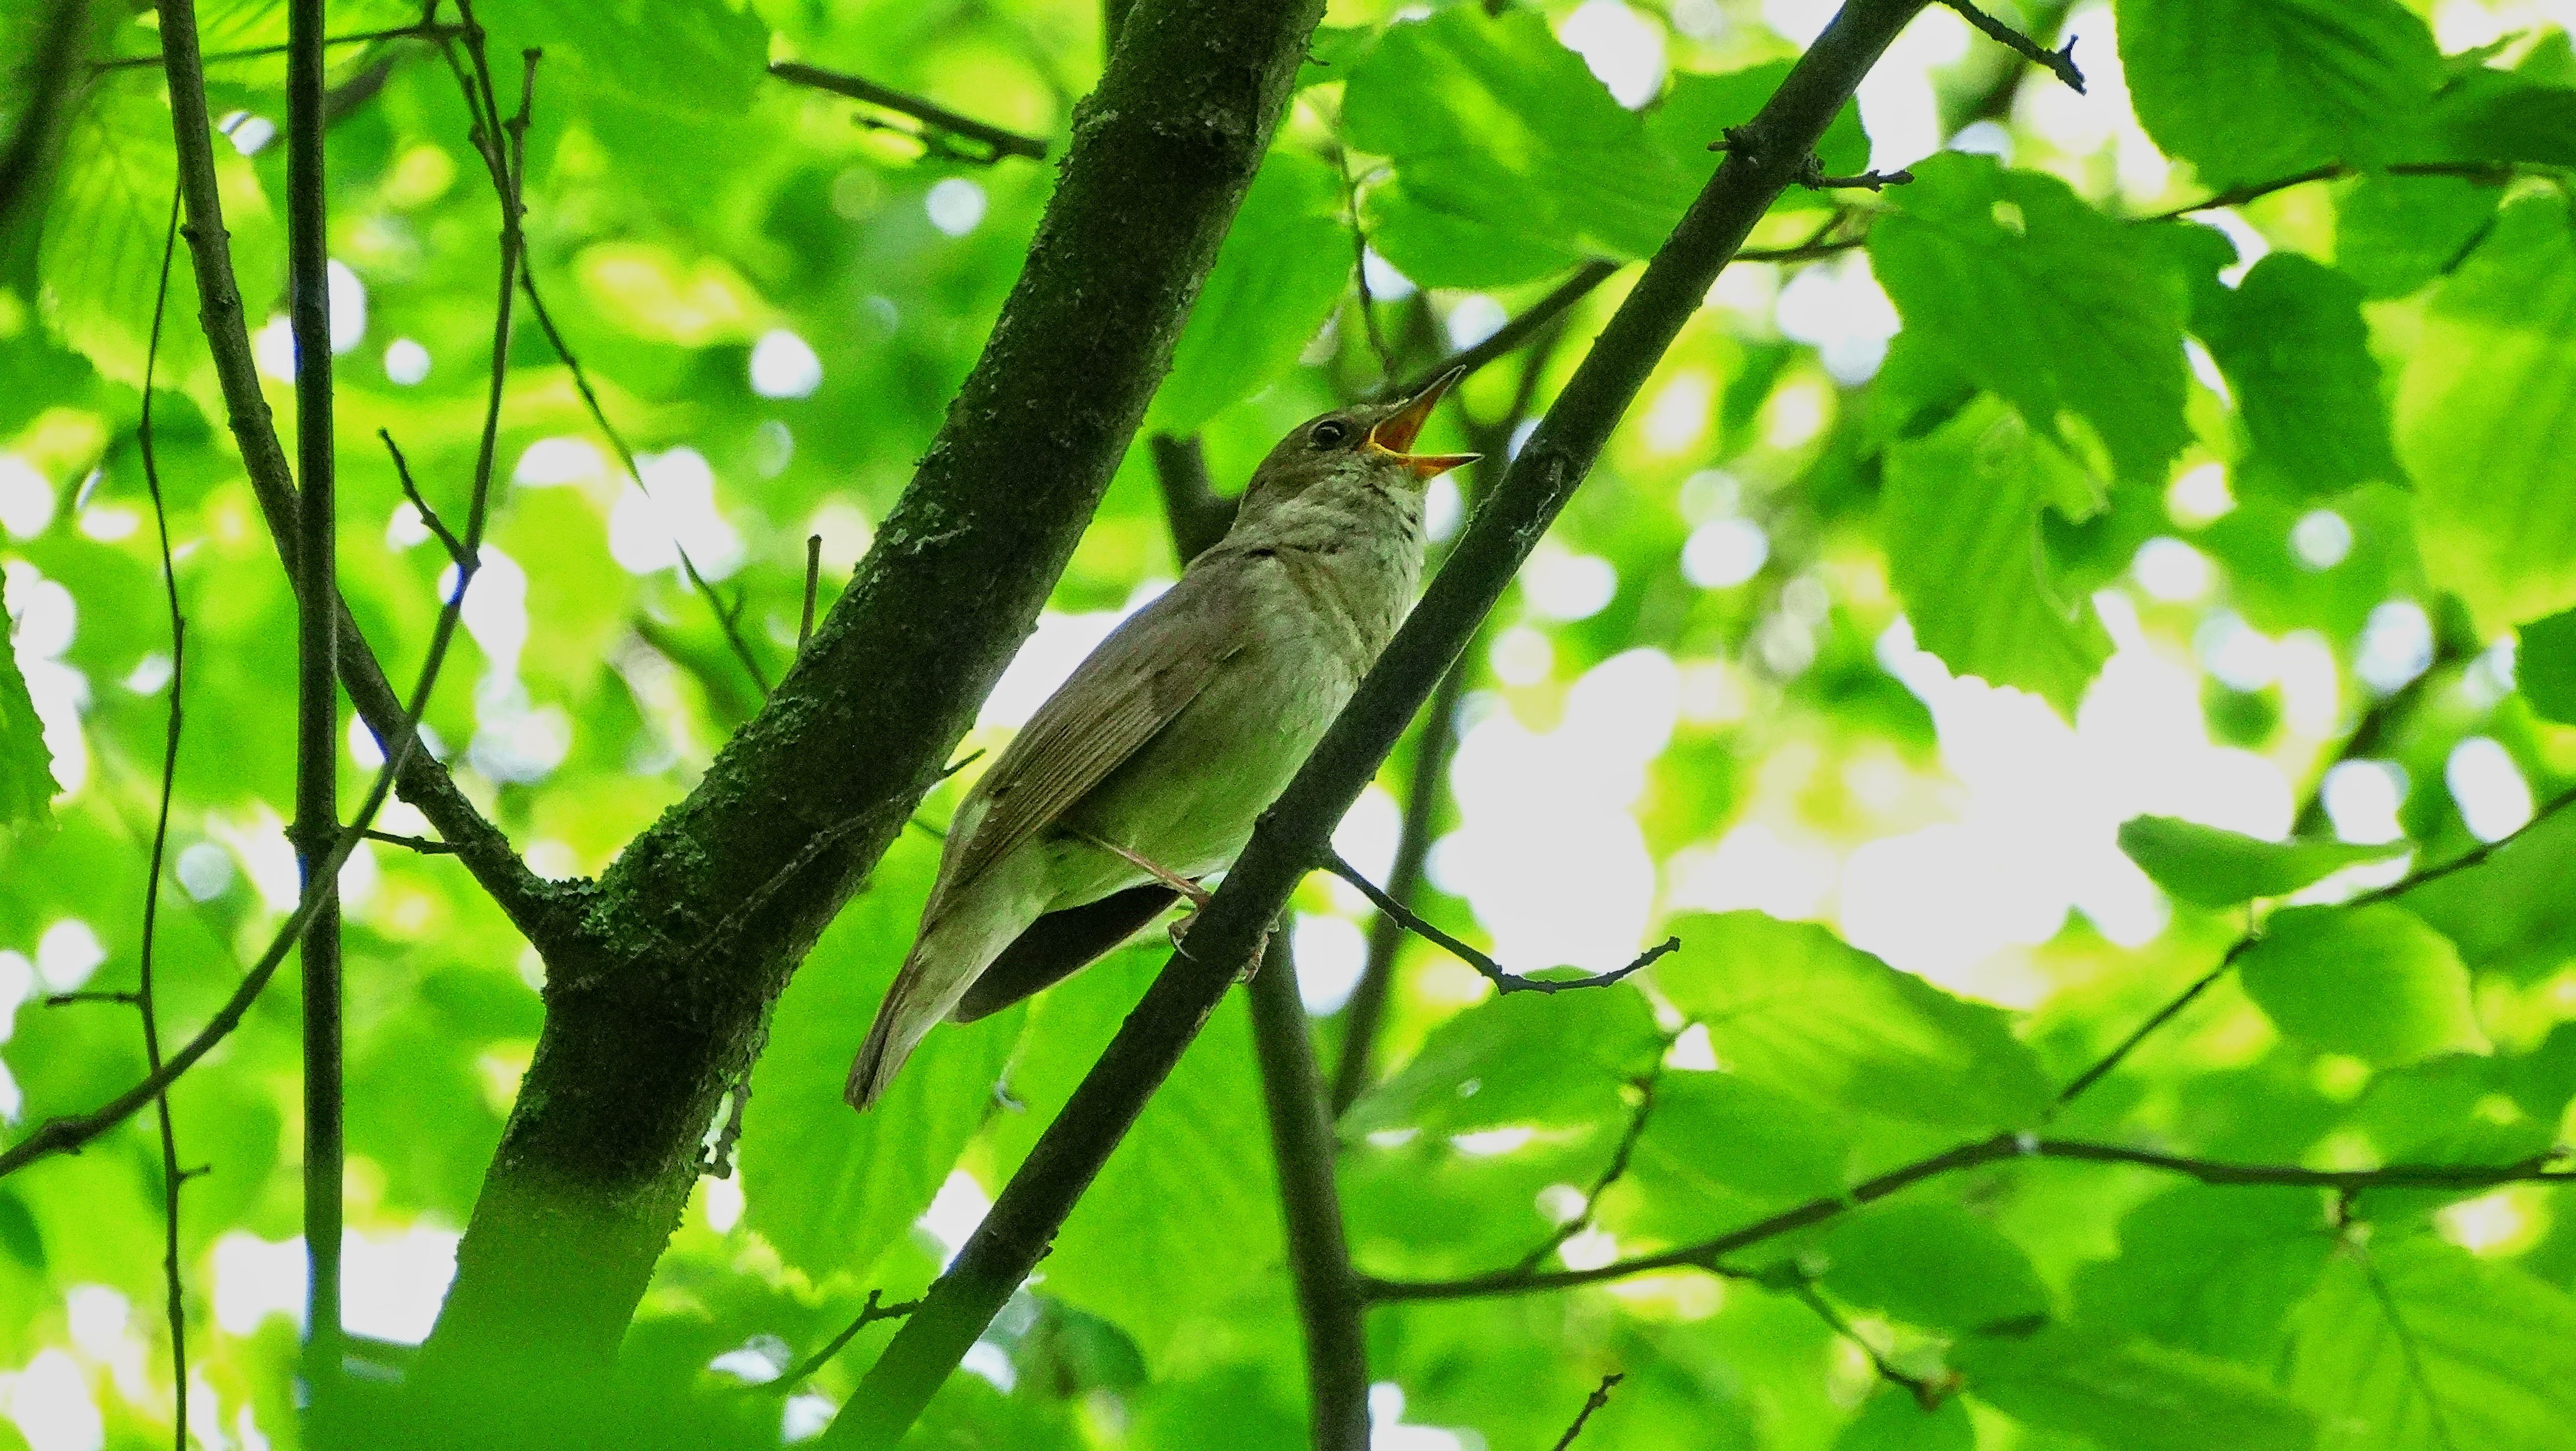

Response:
(0, 0), (2576, 1451)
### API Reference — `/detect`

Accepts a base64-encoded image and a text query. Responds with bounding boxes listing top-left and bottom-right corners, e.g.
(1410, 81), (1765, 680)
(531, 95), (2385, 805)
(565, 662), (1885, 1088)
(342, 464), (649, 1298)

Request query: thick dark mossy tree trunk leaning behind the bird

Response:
(420, 0), (1321, 1392)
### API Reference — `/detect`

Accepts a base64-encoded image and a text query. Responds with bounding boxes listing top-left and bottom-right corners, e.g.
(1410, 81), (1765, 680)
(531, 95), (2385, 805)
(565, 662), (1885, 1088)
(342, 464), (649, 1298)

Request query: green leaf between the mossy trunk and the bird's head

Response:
(1146, 150), (1350, 433)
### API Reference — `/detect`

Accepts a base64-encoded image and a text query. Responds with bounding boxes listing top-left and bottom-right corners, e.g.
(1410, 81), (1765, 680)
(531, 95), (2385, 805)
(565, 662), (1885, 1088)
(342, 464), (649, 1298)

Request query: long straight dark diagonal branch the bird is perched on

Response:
(827, 0), (1922, 1446)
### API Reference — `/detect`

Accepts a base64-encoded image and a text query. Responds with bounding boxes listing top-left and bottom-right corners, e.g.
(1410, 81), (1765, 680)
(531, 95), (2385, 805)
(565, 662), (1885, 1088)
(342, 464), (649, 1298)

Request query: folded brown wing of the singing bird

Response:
(938, 569), (1244, 912)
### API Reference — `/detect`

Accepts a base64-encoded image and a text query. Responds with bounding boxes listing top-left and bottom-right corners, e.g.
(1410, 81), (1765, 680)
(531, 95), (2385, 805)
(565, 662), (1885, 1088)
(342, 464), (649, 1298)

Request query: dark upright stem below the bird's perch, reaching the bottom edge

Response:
(1249, 930), (1368, 1451)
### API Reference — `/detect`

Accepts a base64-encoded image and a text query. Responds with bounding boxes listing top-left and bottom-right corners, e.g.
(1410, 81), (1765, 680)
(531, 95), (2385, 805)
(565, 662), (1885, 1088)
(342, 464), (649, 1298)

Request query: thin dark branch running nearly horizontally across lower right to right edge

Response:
(1360, 1134), (2576, 1304)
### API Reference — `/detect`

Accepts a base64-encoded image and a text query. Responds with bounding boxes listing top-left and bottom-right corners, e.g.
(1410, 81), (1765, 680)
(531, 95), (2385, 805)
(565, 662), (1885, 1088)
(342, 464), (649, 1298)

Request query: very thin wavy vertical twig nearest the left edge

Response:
(134, 180), (188, 1451)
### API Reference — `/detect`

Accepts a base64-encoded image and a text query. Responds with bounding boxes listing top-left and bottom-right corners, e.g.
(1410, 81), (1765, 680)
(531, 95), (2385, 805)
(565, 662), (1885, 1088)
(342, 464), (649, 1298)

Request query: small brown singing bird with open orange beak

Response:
(848, 371), (1476, 1108)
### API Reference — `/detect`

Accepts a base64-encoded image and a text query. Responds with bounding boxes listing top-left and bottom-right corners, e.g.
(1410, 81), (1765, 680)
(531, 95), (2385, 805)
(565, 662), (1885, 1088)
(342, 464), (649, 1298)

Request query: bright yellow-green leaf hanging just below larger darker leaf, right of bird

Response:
(1878, 397), (2110, 719)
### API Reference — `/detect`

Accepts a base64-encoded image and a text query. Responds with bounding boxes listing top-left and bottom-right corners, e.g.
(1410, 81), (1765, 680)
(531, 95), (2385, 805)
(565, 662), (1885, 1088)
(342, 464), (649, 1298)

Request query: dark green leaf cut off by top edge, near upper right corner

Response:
(2120, 0), (2442, 185)
